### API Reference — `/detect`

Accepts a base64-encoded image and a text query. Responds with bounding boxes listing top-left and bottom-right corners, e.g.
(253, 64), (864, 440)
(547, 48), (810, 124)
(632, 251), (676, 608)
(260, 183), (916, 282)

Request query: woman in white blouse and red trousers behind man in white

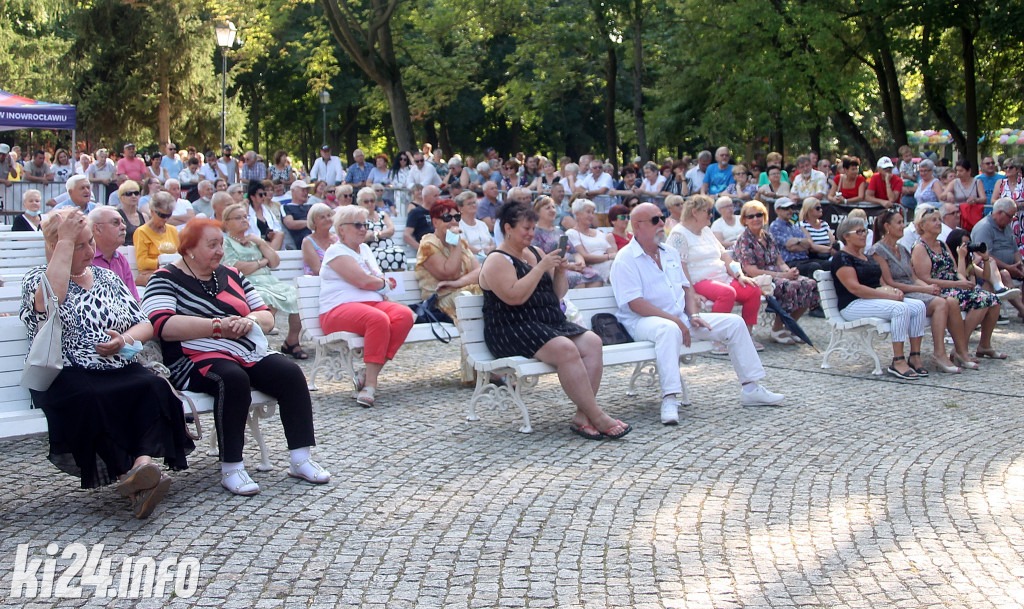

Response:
(668, 194), (765, 354)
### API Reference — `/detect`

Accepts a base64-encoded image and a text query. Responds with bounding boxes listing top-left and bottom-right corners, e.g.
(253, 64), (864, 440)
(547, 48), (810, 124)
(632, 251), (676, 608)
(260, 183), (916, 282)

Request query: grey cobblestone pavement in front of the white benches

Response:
(0, 319), (1024, 609)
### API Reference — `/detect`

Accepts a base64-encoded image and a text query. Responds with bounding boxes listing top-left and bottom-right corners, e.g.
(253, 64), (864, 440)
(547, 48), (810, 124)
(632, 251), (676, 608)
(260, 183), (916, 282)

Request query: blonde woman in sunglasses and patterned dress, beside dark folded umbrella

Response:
(732, 201), (821, 345)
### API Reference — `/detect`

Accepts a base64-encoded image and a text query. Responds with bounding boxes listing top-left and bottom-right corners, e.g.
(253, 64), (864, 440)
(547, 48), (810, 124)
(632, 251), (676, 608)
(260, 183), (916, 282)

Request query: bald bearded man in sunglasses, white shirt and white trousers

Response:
(611, 203), (784, 425)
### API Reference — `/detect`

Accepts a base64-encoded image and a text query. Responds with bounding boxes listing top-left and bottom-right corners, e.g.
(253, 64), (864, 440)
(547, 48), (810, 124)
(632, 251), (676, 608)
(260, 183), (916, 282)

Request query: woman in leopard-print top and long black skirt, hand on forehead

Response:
(20, 209), (195, 518)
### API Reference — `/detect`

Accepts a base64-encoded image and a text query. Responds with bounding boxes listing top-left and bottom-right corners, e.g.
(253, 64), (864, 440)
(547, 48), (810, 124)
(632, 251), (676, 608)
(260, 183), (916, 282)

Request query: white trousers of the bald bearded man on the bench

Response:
(631, 313), (765, 395)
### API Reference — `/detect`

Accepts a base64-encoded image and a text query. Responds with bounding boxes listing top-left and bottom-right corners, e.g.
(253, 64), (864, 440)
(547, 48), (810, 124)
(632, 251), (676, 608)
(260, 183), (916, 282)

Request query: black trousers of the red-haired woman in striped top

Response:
(188, 353), (316, 463)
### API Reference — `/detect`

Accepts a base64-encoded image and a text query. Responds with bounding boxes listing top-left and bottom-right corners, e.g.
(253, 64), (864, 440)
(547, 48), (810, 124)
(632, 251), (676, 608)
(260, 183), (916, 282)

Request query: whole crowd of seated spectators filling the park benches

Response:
(9, 142), (1024, 509)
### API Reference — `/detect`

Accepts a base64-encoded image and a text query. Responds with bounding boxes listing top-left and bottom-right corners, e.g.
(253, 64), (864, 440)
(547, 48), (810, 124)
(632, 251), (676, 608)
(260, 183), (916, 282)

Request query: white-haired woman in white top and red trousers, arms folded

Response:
(319, 205), (414, 408)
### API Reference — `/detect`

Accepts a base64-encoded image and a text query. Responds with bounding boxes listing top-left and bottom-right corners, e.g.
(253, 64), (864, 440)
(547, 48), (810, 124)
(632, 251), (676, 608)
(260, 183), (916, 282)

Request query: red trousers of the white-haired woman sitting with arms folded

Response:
(321, 300), (416, 363)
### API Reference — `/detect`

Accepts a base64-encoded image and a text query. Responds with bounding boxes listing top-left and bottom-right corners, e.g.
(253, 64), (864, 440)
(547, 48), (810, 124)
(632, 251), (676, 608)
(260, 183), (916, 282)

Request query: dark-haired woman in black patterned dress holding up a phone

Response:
(479, 204), (632, 440)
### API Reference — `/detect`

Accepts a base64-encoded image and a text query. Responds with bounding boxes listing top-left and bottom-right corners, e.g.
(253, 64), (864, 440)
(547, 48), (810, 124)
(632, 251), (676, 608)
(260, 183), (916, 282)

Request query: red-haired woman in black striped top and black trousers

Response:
(142, 218), (331, 495)
